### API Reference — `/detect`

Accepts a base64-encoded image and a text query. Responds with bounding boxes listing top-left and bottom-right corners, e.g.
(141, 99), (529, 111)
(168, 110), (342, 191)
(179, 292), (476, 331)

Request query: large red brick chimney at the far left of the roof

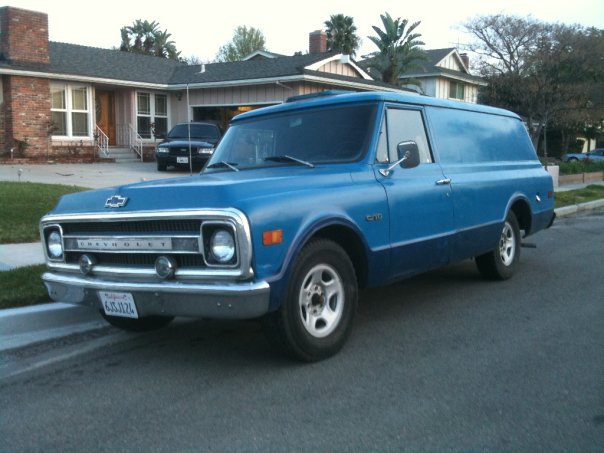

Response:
(0, 6), (49, 64)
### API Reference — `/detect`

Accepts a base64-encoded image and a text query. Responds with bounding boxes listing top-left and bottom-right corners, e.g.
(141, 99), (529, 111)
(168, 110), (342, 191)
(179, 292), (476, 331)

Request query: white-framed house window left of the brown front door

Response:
(50, 83), (91, 137)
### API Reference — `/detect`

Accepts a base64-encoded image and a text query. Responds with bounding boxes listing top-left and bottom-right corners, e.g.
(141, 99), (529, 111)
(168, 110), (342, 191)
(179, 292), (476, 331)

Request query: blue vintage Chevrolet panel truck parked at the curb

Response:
(40, 93), (554, 361)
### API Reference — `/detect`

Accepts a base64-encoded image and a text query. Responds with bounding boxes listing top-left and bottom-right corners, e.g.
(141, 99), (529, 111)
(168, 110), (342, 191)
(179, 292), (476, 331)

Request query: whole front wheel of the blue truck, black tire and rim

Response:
(263, 239), (358, 362)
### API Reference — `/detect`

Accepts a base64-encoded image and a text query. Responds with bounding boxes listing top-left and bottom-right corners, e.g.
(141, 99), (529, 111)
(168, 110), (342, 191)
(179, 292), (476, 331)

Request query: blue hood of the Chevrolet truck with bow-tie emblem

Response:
(49, 164), (359, 215)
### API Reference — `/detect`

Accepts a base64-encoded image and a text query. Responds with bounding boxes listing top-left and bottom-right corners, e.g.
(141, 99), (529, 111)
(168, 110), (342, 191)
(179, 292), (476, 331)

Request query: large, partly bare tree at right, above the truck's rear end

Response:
(464, 15), (604, 152)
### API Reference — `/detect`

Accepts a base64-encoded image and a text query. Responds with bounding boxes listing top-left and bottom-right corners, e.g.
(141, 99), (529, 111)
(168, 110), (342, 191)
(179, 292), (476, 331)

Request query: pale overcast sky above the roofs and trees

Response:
(5, 0), (604, 62)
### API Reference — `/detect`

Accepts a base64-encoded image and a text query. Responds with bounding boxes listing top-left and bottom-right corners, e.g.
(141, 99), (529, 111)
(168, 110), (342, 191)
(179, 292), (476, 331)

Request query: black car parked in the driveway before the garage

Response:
(155, 122), (222, 171)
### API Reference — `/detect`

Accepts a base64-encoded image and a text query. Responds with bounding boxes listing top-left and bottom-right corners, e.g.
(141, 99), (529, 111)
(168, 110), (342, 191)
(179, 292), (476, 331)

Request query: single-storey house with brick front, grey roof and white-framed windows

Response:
(0, 7), (400, 161)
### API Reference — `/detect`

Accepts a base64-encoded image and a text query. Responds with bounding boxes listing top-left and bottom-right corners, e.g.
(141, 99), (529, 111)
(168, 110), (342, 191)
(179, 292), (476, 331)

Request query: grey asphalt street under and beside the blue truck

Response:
(0, 210), (604, 452)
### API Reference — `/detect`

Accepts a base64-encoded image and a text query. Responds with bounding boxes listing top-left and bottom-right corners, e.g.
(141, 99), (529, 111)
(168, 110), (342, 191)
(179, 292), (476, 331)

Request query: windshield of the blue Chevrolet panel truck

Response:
(206, 104), (377, 171)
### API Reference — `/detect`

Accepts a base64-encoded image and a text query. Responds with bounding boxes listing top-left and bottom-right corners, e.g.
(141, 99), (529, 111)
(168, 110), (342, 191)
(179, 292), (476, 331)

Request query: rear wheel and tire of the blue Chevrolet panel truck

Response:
(476, 211), (521, 280)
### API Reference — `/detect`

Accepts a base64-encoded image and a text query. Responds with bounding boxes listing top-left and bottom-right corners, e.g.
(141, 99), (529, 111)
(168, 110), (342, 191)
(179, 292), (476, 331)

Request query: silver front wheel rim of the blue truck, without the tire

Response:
(298, 264), (345, 338)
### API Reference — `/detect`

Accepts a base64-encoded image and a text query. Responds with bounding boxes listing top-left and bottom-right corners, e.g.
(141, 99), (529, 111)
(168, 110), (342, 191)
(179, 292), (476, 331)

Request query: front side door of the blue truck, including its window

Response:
(376, 108), (454, 279)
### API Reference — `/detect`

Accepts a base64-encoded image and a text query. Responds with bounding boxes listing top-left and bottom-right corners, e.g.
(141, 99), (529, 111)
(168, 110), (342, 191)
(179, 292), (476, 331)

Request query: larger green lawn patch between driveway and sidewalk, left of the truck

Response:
(0, 181), (87, 244)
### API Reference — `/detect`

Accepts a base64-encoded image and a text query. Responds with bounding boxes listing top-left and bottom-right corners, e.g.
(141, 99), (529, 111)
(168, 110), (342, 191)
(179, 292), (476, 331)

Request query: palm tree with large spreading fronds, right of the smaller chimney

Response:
(369, 13), (426, 85)
